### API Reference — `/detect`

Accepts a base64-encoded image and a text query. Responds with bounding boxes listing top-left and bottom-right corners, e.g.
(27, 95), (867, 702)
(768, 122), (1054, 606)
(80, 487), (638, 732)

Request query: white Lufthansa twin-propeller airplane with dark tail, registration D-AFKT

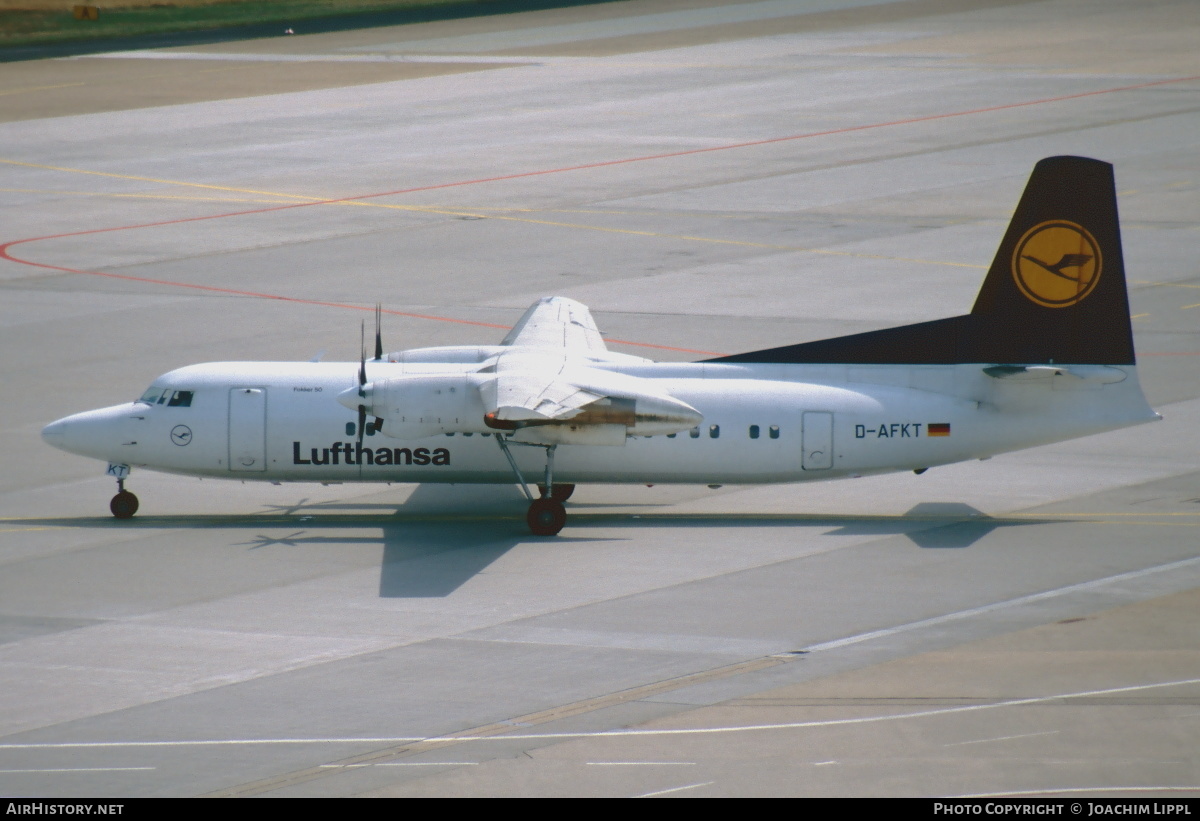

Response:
(42, 157), (1158, 535)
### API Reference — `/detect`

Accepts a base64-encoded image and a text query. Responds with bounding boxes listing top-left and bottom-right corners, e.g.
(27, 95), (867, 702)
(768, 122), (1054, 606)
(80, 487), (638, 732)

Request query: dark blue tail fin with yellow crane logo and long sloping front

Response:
(708, 157), (1134, 365)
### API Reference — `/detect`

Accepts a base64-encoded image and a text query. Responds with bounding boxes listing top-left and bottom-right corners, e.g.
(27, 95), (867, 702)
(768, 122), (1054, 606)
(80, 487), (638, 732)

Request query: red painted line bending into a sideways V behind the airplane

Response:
(0, 74), (1200, 355)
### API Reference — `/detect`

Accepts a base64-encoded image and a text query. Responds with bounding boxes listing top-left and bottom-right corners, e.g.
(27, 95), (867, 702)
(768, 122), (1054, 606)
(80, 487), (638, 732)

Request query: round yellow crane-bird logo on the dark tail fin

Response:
(1013, 220), (1103, 307)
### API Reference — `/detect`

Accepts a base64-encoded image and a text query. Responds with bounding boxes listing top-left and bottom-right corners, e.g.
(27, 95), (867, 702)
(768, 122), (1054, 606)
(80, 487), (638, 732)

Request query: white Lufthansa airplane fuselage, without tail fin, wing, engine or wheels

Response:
(43, 361), (1157, 484)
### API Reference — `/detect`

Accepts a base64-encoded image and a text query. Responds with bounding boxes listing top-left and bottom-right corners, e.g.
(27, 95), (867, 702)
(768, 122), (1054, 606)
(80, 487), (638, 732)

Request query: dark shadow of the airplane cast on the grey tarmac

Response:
(22, 485), (1057, 598)
